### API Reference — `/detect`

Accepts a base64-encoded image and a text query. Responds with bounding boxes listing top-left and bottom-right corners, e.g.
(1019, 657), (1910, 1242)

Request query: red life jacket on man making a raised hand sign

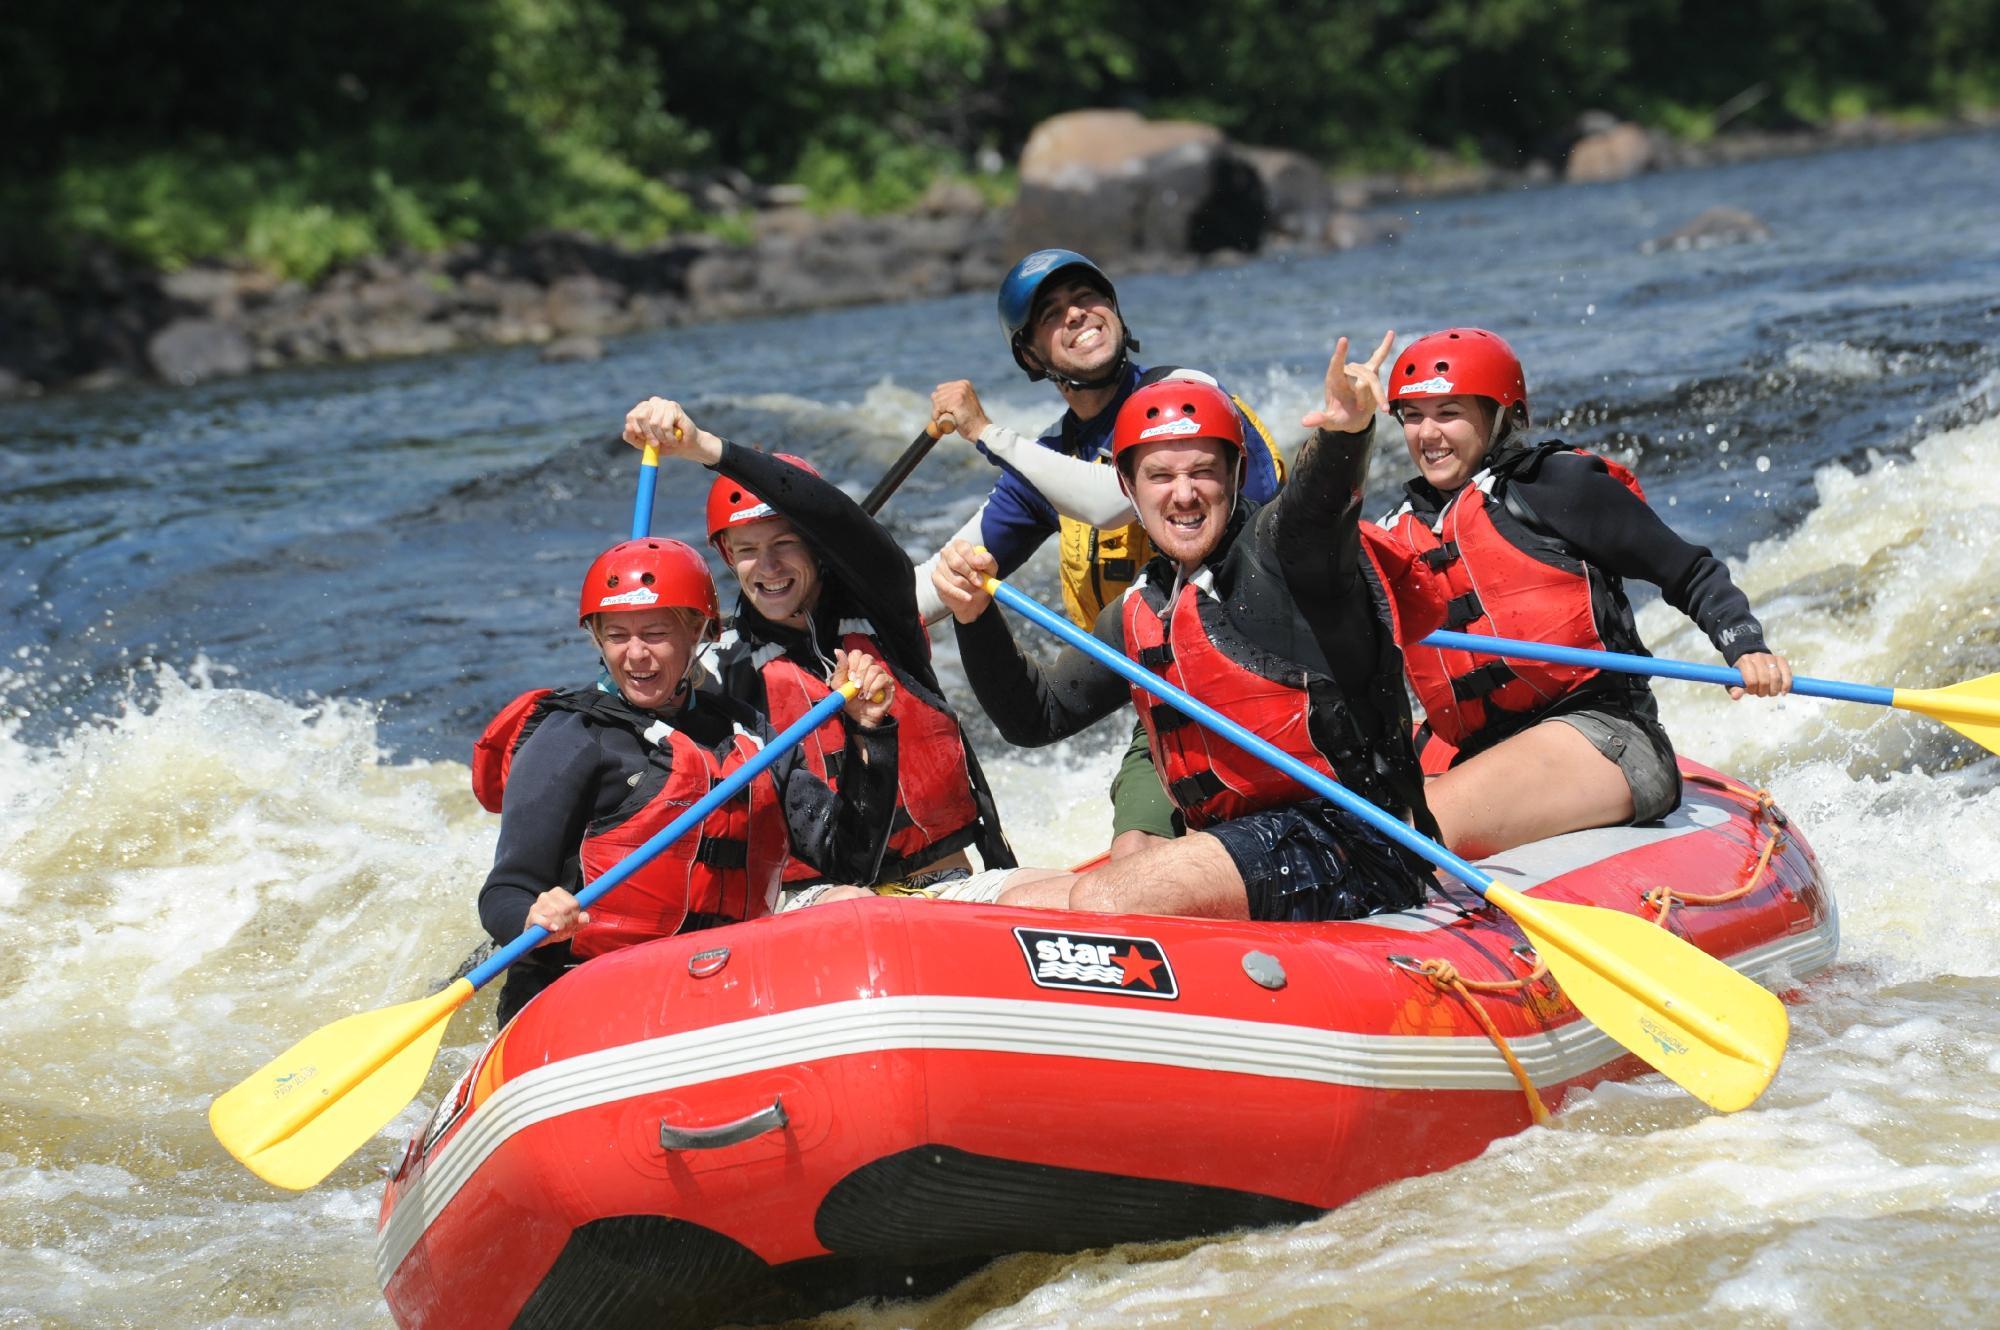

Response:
(1122, 570), (1342, 830)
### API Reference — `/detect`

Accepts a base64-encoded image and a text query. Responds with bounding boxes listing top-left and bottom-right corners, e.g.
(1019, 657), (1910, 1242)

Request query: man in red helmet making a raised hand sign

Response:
(934, 336), (1430, 920)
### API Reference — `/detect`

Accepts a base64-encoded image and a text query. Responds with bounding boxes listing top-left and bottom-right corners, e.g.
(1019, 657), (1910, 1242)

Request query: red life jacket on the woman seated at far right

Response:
(1382, 446), (1646, 748)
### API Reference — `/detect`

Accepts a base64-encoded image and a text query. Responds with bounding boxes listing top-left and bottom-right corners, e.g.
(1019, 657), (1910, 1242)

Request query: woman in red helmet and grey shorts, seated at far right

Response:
(1380, 328), (1792, 856)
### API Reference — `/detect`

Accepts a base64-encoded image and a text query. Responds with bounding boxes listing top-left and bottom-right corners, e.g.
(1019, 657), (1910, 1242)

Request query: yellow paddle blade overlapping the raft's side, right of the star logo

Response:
(1486, 884), (1790, 1112)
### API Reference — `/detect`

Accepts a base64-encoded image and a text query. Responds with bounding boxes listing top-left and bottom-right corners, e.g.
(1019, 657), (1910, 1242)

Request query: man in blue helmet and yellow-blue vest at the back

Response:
(916, 250), (1284, 856)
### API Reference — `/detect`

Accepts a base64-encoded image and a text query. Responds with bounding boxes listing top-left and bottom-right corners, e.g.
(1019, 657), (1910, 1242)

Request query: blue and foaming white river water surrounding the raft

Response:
(11, 134), (2000, 1330)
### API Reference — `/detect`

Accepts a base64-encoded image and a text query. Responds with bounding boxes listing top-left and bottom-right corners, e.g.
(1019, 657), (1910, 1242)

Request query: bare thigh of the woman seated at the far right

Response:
(1424, 720), (1632, 858)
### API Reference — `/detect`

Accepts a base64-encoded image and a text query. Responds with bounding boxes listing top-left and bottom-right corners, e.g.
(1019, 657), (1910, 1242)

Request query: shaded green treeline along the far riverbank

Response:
(0, 0), (2000, 276)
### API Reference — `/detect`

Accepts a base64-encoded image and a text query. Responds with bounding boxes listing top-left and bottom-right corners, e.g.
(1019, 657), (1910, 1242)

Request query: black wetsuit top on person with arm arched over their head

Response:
(714, 440), (1018, 882)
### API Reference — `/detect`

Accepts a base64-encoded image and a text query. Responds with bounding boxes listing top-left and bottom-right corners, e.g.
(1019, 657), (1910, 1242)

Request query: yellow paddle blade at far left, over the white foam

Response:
(208, 980), (472, 1192)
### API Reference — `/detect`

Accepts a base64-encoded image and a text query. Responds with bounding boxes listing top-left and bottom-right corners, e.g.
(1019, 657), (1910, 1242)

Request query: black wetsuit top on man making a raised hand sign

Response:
(958, 424), (1430, 826)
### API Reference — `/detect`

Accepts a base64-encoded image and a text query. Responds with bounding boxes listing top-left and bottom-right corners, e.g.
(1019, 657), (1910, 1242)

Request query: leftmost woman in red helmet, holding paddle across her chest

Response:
(472, 538), (896, 1024)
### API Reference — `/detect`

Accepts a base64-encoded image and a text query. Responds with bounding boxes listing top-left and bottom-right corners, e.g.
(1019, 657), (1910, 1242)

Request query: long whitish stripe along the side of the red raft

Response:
(376, 896), (1840, 1288)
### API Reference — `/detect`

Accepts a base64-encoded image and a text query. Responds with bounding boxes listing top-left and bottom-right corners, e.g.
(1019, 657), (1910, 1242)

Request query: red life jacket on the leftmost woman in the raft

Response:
(472, 688), (790, 958)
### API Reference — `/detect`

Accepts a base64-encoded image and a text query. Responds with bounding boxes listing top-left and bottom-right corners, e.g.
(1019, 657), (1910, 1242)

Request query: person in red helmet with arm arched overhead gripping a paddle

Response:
(624, 398), (1014, 886)
